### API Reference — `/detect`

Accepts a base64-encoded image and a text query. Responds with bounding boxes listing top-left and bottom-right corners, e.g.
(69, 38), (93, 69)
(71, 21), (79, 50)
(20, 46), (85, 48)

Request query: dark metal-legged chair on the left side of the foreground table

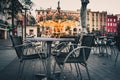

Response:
(10, 36), (47, 80)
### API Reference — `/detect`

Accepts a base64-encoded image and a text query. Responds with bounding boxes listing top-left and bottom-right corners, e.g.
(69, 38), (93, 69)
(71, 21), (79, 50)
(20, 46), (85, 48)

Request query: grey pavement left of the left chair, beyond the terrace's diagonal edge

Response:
(0, 38), (16, 71)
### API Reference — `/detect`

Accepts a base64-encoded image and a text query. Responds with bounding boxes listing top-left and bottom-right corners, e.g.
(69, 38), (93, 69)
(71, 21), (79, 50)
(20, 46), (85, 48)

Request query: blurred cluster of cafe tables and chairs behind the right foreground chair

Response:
(94, 36), (115, 56)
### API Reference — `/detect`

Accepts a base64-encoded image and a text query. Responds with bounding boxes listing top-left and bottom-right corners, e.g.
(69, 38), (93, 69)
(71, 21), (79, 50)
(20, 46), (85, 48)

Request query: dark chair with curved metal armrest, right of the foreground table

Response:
(53, 35), (94, 80)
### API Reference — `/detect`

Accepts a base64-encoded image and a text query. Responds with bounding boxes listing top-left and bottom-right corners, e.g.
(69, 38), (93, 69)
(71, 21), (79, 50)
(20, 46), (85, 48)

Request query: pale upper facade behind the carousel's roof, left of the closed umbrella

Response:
(35, 8), (80, 22)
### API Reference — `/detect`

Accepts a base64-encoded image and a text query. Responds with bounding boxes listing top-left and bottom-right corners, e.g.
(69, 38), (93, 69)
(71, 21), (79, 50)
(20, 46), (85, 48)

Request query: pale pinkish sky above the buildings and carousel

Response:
(32, 0), (120, 14)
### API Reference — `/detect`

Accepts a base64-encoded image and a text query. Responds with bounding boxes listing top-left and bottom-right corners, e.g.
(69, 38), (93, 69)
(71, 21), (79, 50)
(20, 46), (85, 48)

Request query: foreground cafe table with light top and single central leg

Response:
(26, 37), (74, 78)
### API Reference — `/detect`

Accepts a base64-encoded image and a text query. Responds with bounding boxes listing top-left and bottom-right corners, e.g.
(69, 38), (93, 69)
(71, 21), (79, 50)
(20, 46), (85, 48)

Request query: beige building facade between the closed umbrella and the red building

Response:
(87, 9), (107, 33)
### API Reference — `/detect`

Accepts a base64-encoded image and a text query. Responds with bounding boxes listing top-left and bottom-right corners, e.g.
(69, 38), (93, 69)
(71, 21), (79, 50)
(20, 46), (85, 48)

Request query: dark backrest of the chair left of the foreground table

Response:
(10, 36), (24, 59)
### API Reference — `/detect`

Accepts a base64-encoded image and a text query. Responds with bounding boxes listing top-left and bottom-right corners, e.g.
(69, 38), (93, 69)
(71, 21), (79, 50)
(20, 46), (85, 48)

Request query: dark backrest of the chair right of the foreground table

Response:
(78, 35), (95, 60)
